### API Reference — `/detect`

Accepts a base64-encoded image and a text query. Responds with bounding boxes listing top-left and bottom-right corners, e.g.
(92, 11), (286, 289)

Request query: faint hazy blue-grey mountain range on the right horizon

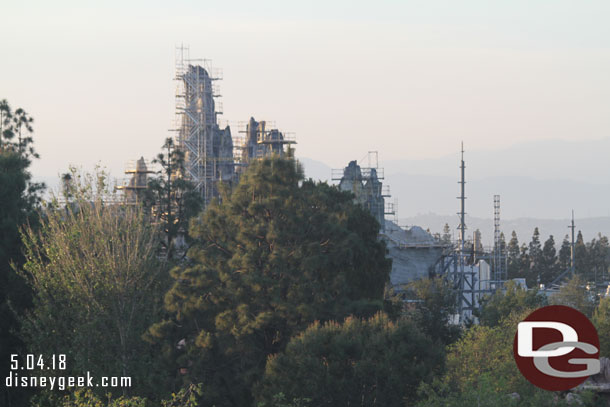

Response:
(299, 138), (610, 243)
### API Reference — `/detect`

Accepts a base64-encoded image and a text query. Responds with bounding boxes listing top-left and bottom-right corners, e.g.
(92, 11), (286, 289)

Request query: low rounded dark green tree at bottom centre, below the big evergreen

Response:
(257, 313), (444, 407)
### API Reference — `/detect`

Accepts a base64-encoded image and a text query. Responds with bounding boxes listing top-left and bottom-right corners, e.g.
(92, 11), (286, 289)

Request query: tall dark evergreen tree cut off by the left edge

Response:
(0, 100), (44, 405)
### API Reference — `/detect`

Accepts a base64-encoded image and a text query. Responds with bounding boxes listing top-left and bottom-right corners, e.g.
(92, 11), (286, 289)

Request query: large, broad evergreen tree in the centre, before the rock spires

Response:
(150, 157), (391, 406)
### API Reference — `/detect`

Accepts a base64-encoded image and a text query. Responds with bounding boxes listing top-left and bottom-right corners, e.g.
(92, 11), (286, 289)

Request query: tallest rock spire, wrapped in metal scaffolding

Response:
(175, 46), (235, 206)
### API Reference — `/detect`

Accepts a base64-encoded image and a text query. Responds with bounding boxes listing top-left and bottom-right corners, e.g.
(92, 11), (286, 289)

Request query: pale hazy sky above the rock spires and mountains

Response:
(0, 0), (610, 182)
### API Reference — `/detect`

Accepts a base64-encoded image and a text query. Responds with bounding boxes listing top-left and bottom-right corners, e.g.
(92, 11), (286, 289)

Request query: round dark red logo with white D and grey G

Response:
(513, 305), (600, 391)
